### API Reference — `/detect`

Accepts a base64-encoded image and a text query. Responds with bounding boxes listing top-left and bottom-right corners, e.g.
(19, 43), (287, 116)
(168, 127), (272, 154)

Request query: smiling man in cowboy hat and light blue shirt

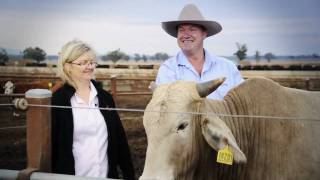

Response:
(156, 4), (243, 99)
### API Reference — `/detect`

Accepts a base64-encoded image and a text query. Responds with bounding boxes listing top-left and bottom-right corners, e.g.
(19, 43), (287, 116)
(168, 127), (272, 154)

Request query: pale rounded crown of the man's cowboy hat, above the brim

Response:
(178, 4), (204, 21)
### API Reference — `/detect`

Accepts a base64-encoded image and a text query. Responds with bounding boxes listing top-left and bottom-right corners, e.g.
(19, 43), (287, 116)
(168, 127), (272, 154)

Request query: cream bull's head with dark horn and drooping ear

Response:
(140, 78), (245, 179)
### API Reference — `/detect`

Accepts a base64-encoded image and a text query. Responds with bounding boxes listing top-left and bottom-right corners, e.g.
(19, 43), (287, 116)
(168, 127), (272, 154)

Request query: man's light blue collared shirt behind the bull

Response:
(156, 50), (244, 100)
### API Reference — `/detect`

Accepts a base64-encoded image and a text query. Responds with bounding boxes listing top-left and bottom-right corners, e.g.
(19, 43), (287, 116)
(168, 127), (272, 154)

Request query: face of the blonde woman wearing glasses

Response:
(65, 53), (97, 83)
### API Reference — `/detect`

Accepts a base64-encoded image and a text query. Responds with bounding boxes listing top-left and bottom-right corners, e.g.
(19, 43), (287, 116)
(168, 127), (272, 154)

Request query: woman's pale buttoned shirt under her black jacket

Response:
(71, 83), (108, 177)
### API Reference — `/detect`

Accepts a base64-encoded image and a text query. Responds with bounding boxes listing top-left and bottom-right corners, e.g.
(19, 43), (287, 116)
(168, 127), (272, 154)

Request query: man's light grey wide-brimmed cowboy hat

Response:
(162, 4), (222, 37)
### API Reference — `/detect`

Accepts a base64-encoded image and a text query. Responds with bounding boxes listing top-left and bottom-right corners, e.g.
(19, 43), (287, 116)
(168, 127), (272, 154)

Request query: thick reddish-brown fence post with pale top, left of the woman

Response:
(25, 89), (52, 172)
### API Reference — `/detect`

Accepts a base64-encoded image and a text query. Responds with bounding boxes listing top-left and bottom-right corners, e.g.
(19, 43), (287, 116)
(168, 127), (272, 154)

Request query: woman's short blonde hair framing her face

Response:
(58, 40), (96, 88)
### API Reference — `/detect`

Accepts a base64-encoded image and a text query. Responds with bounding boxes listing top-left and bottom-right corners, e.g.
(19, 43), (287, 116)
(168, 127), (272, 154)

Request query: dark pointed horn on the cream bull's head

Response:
(197, 77), (226, 97)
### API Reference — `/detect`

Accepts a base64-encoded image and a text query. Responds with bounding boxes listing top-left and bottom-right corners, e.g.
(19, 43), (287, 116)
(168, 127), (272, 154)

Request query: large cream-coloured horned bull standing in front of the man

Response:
(140, 78), (320, 180)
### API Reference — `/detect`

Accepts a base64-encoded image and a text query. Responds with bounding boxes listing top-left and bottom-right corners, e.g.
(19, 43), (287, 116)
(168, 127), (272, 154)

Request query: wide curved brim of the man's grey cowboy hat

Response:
(162, 20), (222, 37)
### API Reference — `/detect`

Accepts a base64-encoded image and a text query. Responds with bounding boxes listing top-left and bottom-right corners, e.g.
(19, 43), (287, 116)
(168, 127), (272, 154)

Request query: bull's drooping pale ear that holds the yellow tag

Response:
(202, 117), (247, 163)
